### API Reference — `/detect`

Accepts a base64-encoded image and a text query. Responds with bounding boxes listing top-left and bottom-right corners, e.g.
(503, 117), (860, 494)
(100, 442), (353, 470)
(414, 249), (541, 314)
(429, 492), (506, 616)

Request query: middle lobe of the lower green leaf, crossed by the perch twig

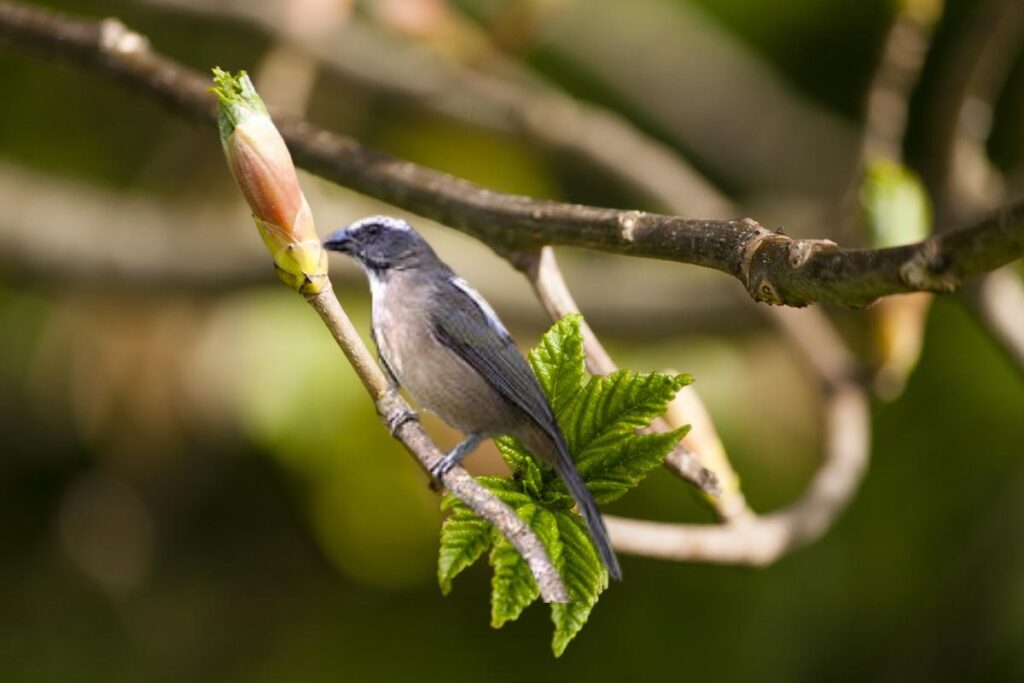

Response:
(489, 503), (561, 629)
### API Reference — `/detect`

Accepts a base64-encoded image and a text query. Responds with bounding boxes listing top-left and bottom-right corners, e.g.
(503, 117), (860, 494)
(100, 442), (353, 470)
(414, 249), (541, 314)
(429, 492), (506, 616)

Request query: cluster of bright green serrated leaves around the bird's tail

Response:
(438, 315), (690, 656)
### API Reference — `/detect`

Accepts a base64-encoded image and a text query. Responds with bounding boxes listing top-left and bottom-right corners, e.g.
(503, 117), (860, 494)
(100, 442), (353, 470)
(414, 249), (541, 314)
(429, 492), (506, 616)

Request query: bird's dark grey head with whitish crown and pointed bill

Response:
(324, 216), (437, 274)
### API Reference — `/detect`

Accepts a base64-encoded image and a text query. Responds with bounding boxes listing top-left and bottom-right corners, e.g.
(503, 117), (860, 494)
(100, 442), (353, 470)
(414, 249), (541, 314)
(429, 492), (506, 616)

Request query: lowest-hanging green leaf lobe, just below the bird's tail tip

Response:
(551, 513), (608, 657)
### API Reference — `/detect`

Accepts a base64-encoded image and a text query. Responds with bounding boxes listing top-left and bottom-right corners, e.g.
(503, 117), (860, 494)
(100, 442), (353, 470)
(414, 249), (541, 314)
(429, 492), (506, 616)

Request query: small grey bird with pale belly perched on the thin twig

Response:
(324, 216), (622, 580)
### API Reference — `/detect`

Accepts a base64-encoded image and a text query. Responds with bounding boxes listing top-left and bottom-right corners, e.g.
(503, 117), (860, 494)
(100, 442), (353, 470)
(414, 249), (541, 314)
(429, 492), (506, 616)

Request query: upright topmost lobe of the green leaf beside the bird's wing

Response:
(529, 313), (586, 415)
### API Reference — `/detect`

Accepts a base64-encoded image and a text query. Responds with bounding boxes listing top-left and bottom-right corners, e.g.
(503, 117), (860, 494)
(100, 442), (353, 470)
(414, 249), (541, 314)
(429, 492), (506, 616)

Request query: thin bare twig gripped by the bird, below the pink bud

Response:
(306, 285), (568, 602)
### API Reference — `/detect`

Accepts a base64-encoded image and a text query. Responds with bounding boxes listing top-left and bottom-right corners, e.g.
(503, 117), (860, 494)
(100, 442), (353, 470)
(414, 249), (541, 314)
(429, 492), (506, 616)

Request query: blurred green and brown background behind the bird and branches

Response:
(0, 0), (1024, 683)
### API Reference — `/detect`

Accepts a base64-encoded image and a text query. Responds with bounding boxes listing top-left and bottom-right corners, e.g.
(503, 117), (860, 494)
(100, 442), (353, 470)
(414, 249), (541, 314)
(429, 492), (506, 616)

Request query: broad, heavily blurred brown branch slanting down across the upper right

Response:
(535, 0), (857, 200)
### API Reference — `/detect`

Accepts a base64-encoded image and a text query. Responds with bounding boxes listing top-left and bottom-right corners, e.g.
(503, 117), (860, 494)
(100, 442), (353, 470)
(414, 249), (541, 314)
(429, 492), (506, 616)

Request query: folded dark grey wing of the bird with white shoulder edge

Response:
(431, 276), (556, 436)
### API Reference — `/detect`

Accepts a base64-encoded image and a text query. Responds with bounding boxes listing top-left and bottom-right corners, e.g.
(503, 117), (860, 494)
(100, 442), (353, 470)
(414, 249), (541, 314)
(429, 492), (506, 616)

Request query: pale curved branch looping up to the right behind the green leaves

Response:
(521, 247), (870, 565)
